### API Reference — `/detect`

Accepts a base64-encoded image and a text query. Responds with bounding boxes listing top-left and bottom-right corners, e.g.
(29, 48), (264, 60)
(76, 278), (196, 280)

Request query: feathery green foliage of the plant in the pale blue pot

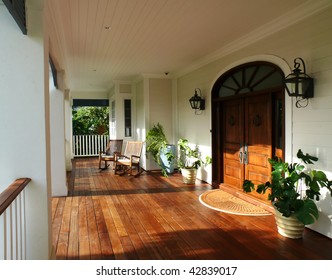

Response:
(146, 123), (175, 177)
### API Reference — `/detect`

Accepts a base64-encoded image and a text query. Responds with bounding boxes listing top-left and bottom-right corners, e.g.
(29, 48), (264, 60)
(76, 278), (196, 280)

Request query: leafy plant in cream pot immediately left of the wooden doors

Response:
(177, 138), (211, 184)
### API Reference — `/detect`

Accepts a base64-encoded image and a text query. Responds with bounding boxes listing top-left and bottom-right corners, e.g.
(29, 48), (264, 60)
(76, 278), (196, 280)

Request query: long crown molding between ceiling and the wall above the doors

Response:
(174, 0), (332, 78)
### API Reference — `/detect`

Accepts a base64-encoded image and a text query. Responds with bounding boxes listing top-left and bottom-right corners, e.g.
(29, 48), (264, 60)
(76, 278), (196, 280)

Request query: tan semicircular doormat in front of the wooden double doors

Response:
(199, 189), (271, 216)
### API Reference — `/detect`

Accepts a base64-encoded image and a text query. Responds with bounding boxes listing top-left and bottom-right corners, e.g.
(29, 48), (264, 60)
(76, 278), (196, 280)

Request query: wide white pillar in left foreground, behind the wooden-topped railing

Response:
(0, 5), (51, 259)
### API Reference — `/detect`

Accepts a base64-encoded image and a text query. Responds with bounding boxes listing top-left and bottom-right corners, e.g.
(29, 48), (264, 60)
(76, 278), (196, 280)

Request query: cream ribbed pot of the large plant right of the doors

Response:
(274, 208), (304, 239)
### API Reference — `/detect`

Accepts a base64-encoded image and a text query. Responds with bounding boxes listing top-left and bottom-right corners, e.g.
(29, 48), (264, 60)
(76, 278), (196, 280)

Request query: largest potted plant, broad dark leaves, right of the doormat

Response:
(243, 149), (332, 238)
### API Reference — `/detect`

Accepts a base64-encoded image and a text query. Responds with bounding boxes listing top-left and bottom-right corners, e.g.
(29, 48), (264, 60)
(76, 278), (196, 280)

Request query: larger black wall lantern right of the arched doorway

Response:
(284, 57), (314, 108)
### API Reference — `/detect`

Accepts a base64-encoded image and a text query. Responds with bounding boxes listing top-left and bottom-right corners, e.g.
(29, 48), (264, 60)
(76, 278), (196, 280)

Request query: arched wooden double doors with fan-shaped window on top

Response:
(212, 61), (285, 201)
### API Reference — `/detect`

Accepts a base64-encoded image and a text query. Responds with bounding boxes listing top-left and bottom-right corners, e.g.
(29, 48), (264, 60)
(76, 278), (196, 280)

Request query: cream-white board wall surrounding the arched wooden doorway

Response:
(177, 8), (332, 237)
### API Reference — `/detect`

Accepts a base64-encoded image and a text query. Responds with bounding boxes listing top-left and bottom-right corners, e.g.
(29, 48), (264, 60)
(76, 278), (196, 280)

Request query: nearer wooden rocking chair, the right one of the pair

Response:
(114, 141), (143, 177)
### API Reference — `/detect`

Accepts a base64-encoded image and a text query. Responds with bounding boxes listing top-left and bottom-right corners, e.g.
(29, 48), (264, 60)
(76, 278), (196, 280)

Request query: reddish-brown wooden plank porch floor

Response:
(52, 158), (332, 260)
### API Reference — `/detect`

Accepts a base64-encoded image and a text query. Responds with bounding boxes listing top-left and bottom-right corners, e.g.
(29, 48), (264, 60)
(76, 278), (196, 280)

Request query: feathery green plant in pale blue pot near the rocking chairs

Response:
(146, 123), (175, 177)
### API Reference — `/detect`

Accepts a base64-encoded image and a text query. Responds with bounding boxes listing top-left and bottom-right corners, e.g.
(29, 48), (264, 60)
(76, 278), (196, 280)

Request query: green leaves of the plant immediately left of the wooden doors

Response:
(177, 138), (212, 169)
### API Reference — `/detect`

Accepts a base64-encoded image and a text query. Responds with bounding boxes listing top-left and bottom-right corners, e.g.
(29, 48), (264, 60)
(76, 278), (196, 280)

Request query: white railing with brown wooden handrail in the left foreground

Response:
(0, 178), (31, 260)
